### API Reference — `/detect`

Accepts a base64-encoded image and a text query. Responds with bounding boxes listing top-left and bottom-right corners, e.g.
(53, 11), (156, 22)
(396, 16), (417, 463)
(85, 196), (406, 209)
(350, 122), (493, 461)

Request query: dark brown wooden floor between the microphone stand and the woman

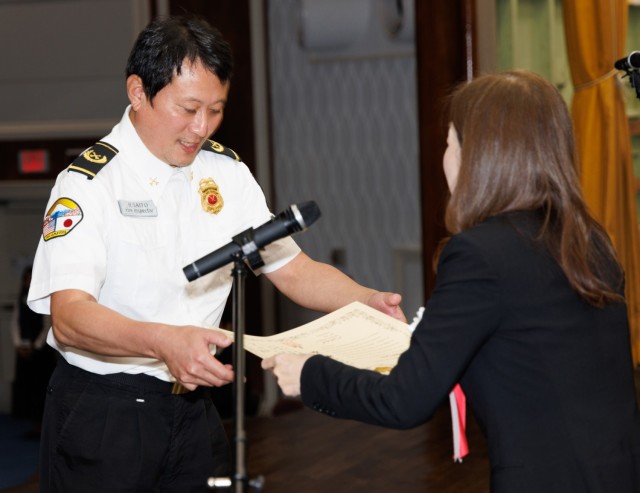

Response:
(0, 371), (640, 493)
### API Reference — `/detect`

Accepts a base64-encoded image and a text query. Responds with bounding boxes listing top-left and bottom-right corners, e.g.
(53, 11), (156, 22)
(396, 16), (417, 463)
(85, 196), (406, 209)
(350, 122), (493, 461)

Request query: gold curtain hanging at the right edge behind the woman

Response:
(563, 0), (640, 364)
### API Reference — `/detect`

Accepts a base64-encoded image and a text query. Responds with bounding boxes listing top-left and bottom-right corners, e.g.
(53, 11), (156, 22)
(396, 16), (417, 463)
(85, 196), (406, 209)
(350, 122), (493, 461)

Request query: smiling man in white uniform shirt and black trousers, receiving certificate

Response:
(29, 13), (404, 493)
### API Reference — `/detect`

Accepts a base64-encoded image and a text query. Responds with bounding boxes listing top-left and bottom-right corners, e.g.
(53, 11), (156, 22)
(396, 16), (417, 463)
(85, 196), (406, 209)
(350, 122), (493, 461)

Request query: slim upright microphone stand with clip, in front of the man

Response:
(207, 230), (264, 493)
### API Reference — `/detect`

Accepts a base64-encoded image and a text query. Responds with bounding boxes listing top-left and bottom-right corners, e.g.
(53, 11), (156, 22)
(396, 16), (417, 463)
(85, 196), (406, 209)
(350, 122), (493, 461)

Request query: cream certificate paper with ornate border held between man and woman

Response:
(216, 302), (411, 373)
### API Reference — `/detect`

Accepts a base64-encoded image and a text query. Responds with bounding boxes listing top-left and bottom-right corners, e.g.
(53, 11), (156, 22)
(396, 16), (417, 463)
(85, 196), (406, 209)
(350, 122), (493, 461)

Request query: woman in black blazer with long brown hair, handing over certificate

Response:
(263, 71), (640, 493)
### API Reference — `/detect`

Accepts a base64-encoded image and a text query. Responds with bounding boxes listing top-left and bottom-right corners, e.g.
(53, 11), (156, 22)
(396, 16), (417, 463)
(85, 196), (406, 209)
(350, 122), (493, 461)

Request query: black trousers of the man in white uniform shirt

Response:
(40, 358), (231, 493)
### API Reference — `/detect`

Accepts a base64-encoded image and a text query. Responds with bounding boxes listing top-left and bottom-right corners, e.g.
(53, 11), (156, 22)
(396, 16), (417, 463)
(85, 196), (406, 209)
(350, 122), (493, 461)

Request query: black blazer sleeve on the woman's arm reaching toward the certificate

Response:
(301, 236), (502, 428)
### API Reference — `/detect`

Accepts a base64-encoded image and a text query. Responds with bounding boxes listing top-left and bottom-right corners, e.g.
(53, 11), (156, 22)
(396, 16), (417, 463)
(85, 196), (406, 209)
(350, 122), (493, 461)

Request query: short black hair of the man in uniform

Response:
(126, 15), (233, 101)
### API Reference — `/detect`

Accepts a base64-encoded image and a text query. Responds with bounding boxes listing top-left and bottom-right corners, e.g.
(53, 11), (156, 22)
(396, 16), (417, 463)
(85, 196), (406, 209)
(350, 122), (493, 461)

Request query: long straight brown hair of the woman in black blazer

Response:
(445, 70), (622, 307)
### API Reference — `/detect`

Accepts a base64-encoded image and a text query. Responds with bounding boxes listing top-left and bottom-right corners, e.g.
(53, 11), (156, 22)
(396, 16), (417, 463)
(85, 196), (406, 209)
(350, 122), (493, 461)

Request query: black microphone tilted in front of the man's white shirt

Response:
(182, 201), (320, 281)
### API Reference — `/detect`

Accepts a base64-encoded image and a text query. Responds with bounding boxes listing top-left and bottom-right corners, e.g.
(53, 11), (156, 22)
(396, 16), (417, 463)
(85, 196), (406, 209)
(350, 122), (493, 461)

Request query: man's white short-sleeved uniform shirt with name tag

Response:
(28, 108), (300, 380)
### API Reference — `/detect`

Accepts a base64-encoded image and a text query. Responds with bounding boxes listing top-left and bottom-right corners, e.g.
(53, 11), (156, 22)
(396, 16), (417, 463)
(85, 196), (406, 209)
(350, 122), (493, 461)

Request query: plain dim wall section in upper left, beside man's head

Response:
(0, 0), (149, 139)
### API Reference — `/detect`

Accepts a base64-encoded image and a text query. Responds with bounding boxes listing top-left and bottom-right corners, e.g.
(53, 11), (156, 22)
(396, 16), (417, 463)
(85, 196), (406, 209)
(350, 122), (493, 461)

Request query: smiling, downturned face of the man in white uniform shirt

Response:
(127, 60), (229, 166)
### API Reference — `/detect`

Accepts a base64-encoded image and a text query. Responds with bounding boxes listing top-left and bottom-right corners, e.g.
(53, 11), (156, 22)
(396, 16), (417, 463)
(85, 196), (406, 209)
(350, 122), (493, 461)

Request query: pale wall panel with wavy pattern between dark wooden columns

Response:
(268, 0), (422, 328)
